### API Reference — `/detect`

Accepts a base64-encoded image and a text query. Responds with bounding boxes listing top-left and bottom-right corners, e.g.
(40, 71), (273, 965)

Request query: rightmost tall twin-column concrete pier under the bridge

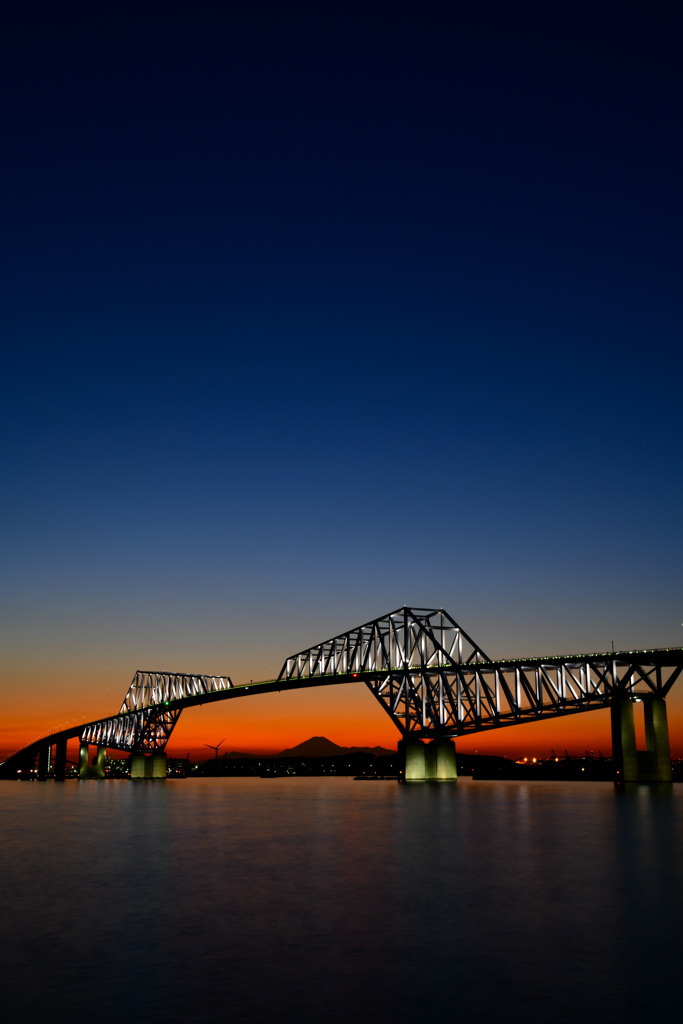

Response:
(611, 696), (672, 782)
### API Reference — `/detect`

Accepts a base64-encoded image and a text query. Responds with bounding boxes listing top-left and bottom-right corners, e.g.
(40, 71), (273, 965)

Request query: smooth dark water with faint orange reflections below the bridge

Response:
(0, 778), (683, 1024)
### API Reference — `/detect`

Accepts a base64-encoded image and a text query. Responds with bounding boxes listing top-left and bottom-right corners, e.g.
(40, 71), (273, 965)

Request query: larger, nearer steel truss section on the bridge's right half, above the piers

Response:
(279, 608), (683, 738)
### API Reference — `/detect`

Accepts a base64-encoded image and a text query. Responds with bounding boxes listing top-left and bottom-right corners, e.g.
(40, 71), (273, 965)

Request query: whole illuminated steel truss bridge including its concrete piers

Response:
(0, 607), (683, 782)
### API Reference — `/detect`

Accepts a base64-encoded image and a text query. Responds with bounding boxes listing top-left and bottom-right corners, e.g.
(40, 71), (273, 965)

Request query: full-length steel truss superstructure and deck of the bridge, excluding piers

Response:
(3, 607), (683, 770)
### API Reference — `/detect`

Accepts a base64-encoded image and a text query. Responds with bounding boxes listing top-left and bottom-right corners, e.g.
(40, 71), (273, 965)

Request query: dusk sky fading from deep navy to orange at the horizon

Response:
(0, 0), (683, 756)
